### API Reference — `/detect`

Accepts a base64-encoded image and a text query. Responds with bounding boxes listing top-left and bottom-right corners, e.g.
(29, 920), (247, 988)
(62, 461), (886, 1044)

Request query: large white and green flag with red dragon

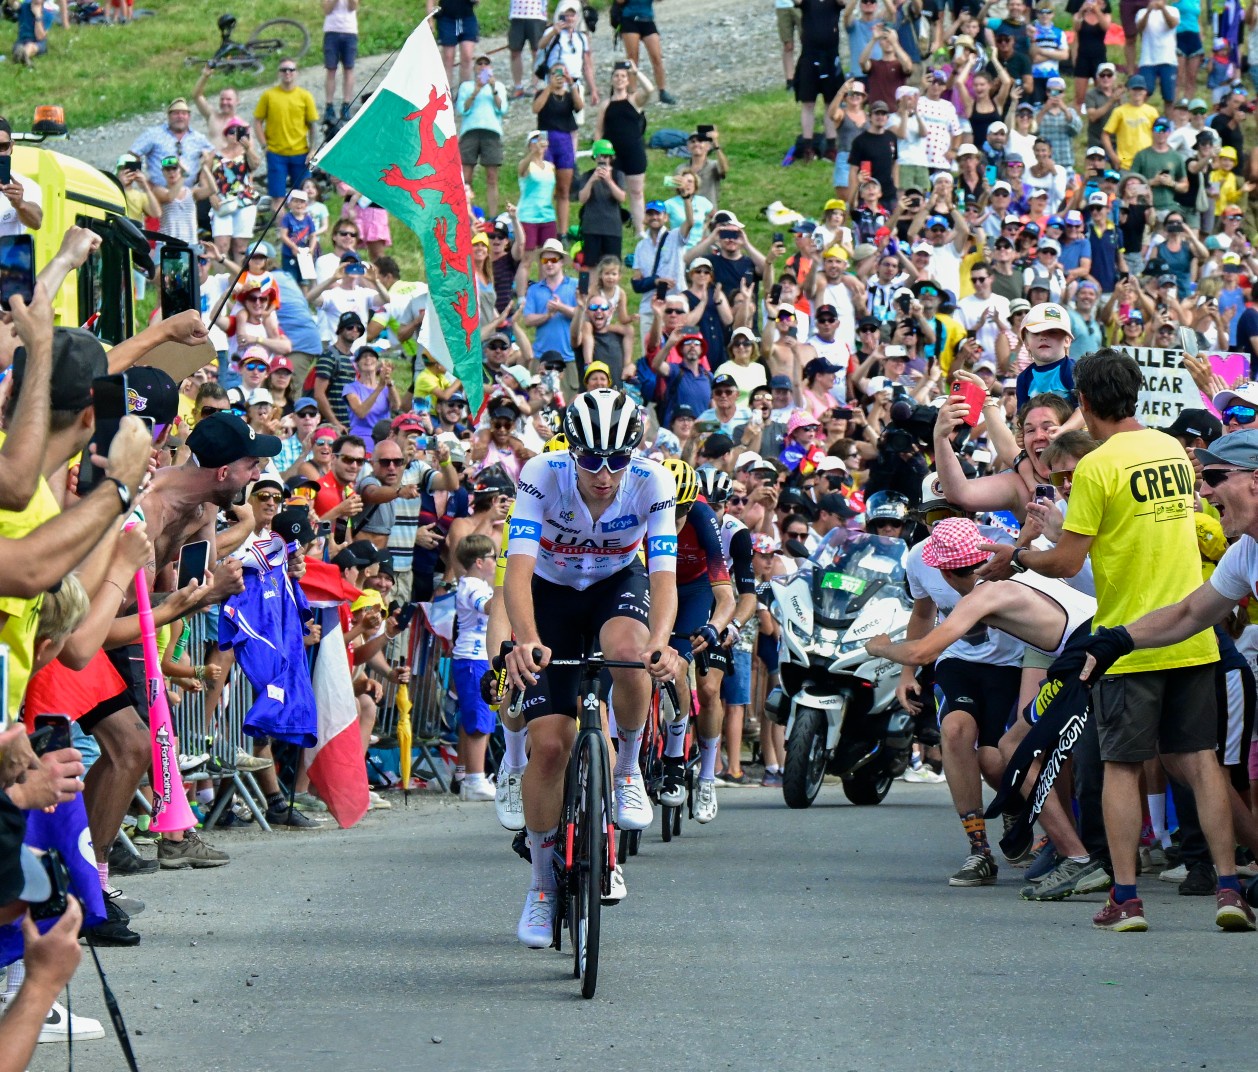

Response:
(318, 20), (482, 411)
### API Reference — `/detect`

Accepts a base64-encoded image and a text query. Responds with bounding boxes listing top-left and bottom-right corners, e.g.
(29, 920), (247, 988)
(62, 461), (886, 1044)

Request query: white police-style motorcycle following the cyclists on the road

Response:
(765, 533), (913, 808)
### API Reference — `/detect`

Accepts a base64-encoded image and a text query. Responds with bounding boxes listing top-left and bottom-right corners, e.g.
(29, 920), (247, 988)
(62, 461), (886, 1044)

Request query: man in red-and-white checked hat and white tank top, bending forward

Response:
(866, 517), (1110, 901)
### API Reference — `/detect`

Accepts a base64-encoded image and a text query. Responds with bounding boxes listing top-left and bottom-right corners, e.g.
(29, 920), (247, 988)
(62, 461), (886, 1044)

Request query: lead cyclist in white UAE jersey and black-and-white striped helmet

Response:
(503, 389), (678, 949)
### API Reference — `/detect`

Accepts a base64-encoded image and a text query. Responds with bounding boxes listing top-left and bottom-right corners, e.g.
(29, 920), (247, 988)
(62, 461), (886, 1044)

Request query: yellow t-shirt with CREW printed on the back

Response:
(1066, 428), (1219, 673)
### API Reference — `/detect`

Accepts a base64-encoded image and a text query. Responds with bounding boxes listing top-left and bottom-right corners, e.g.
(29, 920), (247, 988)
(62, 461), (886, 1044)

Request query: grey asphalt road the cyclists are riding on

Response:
(30, 783), (1258, 1072)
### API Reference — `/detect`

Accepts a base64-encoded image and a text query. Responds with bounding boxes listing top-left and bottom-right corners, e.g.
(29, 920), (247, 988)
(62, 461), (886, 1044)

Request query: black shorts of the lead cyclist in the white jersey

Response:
(522, 564), (650, 721)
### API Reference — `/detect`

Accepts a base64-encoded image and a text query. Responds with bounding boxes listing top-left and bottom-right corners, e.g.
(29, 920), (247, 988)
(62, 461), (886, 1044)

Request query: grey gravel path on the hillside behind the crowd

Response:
(64, 0), (782, 170)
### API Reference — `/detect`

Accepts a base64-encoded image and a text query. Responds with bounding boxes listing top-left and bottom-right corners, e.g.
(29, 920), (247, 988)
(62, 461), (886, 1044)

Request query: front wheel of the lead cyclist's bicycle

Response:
(569, 734), (608, 998)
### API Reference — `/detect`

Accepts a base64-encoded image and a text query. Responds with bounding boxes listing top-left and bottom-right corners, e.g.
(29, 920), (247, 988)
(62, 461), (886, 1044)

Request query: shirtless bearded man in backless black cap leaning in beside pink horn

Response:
(79, 413), (281, 910)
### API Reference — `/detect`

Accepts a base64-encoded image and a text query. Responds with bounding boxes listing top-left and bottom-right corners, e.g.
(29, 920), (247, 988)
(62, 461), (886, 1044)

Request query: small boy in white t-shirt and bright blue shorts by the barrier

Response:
(450, 532), (498, 800)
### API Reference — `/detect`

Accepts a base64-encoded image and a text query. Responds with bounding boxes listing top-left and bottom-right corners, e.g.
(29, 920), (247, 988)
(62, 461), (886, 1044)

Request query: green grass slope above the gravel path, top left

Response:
(0, 0), (509, 130)
